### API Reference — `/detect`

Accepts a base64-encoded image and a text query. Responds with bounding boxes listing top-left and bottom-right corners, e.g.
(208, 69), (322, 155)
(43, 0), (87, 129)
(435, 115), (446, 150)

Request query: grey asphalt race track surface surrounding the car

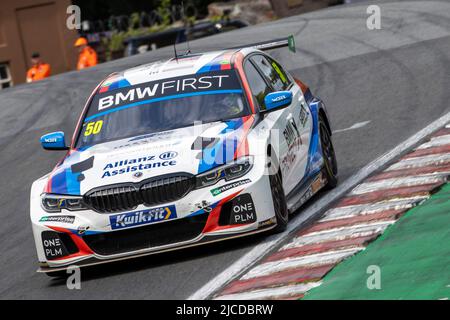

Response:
(0, 1), (450, 299)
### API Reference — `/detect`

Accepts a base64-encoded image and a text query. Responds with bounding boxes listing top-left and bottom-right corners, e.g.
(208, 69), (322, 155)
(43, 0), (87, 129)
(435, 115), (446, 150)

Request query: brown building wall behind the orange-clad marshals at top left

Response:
(0, 0), (77, 84)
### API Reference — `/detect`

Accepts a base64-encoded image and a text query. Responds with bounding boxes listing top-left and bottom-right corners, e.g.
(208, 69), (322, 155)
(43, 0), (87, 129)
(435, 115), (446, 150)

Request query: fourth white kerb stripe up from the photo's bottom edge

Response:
(319, 196), (428, 222)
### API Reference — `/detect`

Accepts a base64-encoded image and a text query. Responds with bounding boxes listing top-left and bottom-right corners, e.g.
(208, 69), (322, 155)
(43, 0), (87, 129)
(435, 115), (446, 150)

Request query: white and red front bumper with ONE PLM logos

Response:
(31, 172), (276, 272)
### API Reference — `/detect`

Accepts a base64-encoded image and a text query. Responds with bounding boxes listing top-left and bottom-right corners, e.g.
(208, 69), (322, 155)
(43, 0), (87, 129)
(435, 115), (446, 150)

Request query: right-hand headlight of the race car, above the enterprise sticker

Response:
(196, 156), (253, 188)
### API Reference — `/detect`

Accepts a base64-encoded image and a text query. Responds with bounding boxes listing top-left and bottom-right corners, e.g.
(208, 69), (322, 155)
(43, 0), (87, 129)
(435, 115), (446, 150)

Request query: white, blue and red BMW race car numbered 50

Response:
(30, 37), (337, 275)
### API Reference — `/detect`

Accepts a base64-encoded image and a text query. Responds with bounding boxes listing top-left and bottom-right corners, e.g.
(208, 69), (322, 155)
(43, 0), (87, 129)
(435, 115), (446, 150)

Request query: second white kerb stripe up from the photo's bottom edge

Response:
(241, 247), (364, 280)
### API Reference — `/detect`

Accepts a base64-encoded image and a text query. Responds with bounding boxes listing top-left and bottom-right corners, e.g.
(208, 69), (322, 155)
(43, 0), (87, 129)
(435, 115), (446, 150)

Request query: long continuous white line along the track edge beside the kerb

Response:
(188, 112), (450, 300)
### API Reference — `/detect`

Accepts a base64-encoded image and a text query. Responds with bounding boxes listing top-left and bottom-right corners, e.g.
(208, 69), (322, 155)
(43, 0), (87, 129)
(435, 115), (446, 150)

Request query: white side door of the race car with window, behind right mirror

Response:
(250, 54), (312, 193)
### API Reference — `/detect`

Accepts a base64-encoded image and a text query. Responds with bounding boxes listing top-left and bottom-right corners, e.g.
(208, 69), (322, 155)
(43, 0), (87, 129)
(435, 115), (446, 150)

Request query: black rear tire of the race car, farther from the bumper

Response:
(319, 116), (338, 189)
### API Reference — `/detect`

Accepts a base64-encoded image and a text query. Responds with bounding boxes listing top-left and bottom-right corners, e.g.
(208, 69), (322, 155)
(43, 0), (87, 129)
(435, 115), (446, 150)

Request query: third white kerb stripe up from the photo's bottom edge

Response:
(280, 220), (395, 251)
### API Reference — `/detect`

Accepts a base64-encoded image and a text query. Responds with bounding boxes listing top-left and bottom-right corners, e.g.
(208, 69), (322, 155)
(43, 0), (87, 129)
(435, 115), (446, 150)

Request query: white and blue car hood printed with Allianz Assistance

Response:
(44, 116), (254, 195)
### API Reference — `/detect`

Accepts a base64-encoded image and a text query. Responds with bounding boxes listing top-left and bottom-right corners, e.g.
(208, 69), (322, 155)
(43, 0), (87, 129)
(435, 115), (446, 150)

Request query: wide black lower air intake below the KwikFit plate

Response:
(83, 213), (208, 256)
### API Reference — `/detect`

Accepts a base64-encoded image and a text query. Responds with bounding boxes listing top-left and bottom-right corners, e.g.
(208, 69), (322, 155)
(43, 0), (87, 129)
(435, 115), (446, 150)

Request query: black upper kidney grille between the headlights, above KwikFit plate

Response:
(84, 173), (195, 213)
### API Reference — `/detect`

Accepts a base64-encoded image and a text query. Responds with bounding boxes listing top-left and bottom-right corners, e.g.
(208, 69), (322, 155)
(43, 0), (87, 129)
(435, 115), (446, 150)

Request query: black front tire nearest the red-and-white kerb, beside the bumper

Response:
(269, 172), (289, 233)
